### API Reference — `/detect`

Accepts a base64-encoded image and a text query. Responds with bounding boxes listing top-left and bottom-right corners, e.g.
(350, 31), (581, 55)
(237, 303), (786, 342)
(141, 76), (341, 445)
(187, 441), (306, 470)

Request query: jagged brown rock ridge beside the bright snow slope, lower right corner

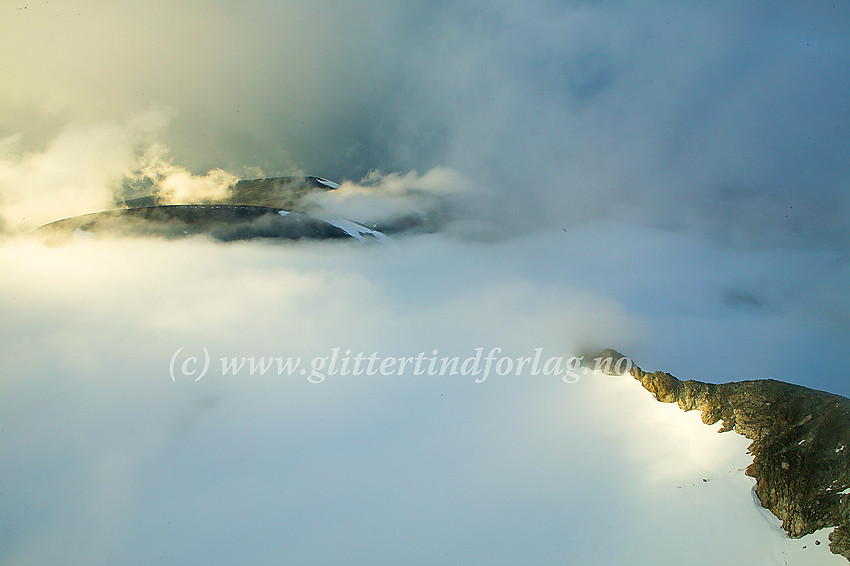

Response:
(585, 350), (850, 561)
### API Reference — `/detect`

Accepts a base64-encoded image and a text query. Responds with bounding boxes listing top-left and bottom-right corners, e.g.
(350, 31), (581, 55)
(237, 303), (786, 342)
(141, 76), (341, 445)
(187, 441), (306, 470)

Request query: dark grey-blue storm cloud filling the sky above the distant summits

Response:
(2, 1), (850, 244)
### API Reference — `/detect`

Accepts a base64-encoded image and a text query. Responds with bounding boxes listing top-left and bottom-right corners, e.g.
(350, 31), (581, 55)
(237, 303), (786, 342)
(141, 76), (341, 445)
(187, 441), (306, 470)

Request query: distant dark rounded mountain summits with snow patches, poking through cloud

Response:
(36, 177), (444, 244)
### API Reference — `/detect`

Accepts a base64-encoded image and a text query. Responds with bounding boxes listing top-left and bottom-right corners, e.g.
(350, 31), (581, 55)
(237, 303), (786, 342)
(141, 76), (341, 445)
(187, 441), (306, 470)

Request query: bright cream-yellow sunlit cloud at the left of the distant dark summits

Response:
(0, 107), (245, 233)
